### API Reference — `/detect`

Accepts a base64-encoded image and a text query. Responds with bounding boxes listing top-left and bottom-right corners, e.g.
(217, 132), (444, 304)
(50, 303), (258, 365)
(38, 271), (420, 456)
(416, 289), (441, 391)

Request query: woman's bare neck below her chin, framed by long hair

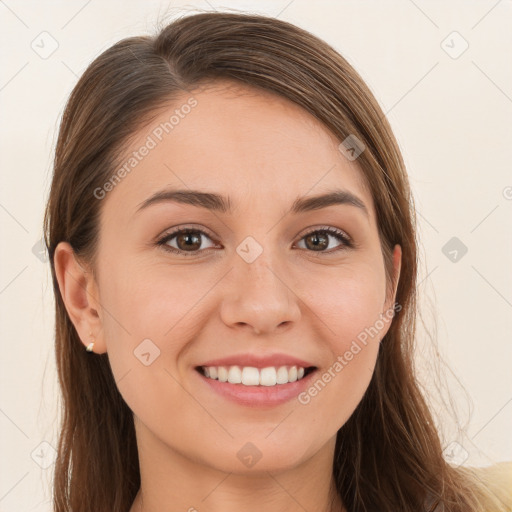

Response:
(130, 422), (345, 512)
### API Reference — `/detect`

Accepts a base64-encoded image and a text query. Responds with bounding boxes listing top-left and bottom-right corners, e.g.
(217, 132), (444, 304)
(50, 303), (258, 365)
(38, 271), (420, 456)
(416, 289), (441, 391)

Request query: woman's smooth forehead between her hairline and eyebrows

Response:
(104, 81), (373, 221)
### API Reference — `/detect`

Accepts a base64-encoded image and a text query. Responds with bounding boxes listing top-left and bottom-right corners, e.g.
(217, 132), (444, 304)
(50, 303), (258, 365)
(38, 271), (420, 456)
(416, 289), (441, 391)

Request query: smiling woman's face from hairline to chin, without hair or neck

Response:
(78, 83), (400, 472)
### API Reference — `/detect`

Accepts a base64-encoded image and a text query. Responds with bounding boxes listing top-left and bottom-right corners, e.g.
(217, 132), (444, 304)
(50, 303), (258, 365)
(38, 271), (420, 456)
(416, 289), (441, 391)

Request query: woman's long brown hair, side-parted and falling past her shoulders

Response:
(44, 12), (504, 512)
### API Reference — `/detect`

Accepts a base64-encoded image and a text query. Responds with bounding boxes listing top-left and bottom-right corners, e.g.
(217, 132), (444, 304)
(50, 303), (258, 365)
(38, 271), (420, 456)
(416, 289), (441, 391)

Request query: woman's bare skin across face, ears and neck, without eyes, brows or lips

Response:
(55, 82), (401, 512)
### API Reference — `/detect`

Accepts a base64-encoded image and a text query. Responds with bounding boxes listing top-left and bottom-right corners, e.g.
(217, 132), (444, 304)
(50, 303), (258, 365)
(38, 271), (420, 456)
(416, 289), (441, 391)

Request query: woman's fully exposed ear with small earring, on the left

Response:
(53, 242), (107, 354)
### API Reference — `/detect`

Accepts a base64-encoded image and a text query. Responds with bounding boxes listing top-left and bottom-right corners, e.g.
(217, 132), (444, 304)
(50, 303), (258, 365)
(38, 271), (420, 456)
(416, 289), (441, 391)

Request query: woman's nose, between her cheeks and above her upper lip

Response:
(221, 253), (301, 334)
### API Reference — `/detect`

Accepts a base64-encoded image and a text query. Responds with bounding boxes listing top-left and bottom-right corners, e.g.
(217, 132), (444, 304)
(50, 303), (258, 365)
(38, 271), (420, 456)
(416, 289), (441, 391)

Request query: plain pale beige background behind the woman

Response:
(0, 0), (512, 512)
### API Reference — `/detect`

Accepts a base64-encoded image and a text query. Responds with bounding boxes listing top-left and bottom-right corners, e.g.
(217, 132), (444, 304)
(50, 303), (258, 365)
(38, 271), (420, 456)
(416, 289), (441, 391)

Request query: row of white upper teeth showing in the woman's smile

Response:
(201, 366), (304, 386)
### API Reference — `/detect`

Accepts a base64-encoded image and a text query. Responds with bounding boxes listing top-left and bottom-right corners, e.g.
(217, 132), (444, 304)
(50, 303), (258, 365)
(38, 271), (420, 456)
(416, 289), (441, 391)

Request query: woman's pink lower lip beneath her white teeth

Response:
(194, 370), (317, 407)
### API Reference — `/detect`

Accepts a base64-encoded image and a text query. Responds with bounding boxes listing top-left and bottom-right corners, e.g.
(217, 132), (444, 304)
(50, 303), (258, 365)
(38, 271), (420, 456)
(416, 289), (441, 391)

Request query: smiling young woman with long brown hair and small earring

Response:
(45, 9), (511, 512)
